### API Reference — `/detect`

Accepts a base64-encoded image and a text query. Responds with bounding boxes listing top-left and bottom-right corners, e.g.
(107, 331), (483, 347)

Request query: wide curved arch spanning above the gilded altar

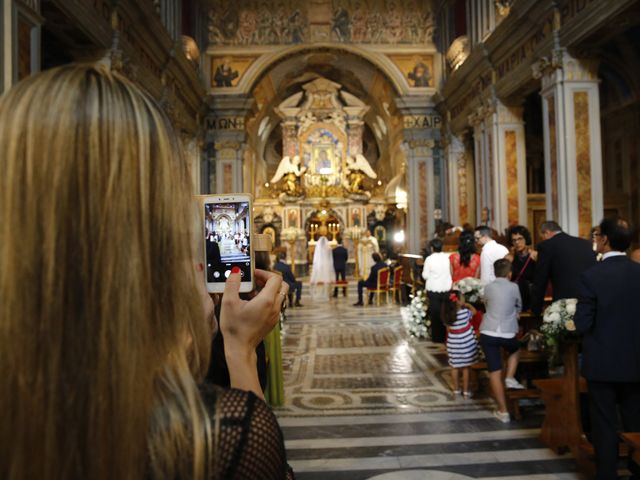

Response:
(210, 43), (409, 96)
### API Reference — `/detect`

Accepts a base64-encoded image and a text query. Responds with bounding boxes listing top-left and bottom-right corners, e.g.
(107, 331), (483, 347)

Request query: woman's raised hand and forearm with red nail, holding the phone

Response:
(220, 269), (289, 398)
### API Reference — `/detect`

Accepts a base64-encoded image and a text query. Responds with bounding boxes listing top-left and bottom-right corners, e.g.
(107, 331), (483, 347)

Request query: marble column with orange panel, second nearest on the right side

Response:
(469, 99), (527, 232)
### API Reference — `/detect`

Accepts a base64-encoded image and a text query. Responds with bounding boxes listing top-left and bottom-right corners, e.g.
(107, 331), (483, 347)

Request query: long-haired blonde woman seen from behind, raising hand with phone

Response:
(0, 65), (290, 480)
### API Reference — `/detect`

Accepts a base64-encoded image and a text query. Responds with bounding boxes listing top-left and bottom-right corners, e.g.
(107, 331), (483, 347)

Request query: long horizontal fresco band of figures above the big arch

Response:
(208, 0), (434, 46)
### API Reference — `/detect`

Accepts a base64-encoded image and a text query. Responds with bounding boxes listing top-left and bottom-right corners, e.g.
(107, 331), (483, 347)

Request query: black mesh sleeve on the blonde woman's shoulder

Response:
(203, 387), (294, 480)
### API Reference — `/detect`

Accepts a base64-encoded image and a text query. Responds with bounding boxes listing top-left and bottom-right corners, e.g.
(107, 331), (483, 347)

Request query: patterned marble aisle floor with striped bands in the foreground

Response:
(276, 285), (580, 480)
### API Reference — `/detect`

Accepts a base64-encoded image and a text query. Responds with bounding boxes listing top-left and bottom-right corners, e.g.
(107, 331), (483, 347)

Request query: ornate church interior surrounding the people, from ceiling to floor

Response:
(0, 0), (640, 480)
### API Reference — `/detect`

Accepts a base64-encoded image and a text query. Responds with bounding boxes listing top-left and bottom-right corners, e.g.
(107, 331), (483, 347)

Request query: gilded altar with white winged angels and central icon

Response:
(255, 77), (385, 271)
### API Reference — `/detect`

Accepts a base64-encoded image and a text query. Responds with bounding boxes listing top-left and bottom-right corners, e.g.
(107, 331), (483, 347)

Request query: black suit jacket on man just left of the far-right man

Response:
(531, 232), (596, 314)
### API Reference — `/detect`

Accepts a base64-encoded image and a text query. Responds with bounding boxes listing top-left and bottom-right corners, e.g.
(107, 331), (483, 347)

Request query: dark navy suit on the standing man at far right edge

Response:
(575, 256), (640, 480)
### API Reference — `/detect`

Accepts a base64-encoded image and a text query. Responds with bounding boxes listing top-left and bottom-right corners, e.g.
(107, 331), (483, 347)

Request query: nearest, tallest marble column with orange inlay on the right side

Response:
(533, 49), (604, 238)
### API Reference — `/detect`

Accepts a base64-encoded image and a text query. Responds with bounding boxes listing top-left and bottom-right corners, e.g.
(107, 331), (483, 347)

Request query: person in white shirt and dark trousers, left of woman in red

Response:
(422, 238), (453, 343)
